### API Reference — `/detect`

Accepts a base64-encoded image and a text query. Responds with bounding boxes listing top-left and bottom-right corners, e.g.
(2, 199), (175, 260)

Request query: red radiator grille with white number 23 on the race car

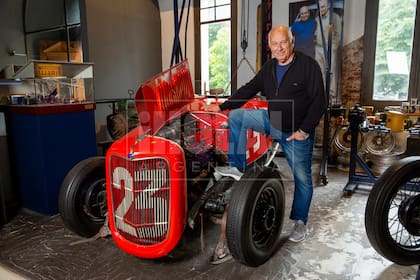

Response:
(110, 156), (170, 245)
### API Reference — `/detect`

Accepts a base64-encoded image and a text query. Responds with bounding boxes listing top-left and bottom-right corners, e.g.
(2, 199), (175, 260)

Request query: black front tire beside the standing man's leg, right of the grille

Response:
(226, 168), (285, 267)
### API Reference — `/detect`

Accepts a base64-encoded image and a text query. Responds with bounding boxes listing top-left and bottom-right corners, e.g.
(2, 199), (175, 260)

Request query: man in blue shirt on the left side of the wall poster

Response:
(290, 6), (316, 57)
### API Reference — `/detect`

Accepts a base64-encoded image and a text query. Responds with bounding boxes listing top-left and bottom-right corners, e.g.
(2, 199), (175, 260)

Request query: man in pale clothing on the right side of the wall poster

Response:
(315, 0), (341, 103)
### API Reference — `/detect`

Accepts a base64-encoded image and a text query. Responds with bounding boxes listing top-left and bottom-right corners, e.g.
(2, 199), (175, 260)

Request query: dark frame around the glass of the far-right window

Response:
(360, 0), (420, 111)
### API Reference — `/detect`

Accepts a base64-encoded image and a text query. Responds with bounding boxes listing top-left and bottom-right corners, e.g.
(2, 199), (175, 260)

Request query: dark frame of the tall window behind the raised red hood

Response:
(194, 0), (238, 95)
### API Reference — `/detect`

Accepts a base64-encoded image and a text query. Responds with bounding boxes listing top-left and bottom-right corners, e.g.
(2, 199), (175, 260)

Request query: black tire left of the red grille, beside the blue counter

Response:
(58, 157), (107, 237)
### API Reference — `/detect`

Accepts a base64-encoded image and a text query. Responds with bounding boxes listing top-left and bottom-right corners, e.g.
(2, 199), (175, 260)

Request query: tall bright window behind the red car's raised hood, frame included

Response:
(195, 0), (237, 95)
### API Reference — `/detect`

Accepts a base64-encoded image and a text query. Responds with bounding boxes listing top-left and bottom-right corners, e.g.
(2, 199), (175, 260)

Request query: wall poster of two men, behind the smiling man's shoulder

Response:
(289, 0), (344, 105)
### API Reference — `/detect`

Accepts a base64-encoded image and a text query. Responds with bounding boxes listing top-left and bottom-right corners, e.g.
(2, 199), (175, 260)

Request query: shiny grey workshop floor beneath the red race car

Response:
(0, 158), (417, 280)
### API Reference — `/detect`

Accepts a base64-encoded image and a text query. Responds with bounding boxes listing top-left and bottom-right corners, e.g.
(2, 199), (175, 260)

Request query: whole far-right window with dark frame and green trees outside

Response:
(361, 0), (420, 110)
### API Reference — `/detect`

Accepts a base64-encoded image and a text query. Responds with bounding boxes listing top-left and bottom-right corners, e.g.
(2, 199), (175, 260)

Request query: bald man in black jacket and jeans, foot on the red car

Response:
(203, 25), (326, 262)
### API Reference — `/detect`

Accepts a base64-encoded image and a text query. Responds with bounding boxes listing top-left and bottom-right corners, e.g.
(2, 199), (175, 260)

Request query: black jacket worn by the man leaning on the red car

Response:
(220, 52), (327, 133)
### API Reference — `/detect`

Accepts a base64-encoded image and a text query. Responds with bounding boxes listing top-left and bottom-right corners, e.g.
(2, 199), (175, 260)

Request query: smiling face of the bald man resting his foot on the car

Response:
(270, 29), (293, 64)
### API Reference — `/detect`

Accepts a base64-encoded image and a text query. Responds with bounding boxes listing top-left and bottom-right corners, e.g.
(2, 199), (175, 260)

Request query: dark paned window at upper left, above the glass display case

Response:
(25, 0), (83, 62)
